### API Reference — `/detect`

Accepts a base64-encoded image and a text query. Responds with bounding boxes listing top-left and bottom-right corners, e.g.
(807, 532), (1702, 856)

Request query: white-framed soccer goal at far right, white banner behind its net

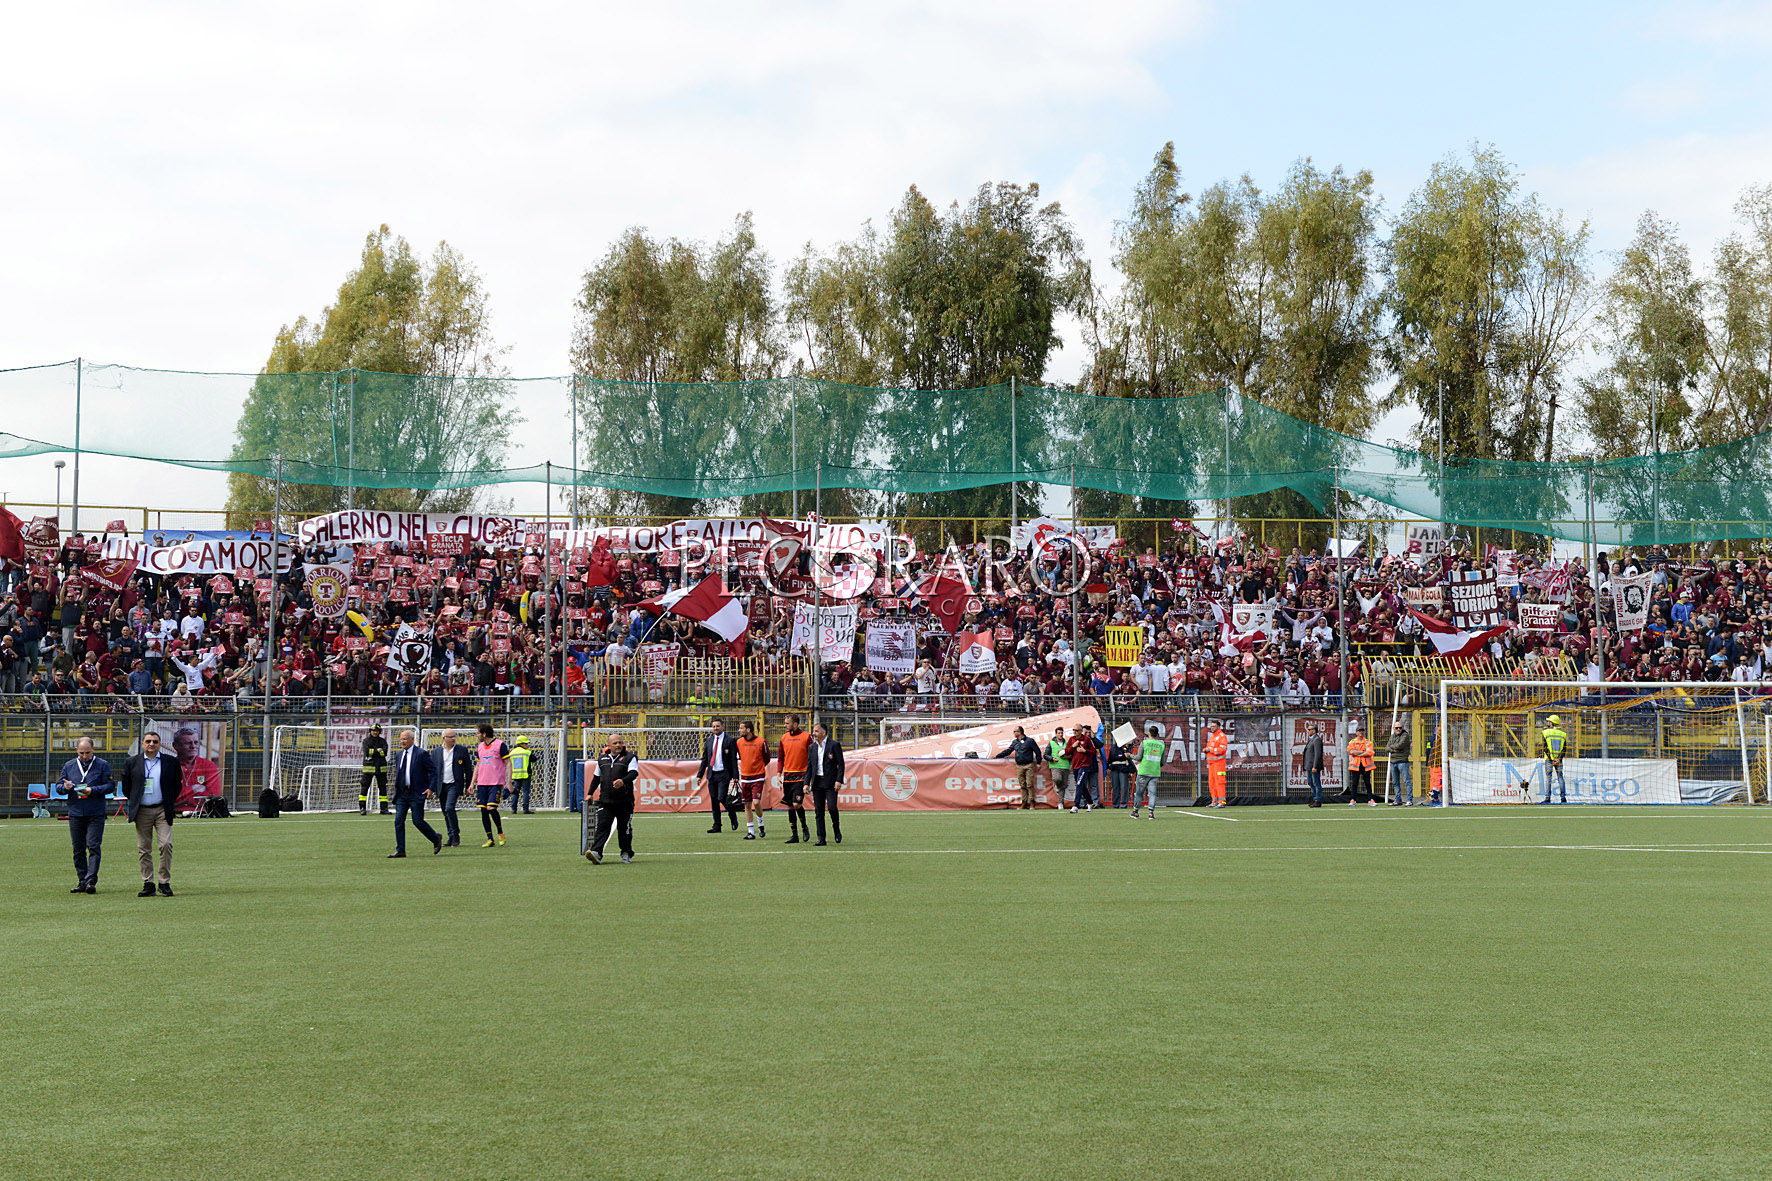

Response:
(1437, 679), (1772, 803)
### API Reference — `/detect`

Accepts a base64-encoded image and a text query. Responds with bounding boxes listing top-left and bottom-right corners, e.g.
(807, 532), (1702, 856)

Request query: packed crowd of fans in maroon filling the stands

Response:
(0, 521), (1772, 709)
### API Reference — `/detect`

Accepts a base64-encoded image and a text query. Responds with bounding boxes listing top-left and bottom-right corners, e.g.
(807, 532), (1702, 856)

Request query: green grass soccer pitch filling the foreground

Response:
(0, 807), (1772, 1181)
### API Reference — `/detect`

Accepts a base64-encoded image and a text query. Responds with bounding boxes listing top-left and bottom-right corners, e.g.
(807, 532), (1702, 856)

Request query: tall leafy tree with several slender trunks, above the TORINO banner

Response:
(1384, 147), (1588, 459)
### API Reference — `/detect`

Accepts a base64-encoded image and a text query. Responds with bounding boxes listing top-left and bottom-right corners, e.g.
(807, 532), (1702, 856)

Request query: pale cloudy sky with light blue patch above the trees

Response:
(0, 0), (1772, 517)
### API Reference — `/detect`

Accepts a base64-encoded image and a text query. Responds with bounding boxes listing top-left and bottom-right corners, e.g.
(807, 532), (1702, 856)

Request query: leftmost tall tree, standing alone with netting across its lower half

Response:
(227, 225), (516, 523)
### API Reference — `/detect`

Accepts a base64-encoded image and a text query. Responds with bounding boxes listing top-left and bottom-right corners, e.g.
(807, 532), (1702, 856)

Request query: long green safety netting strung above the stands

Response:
(0, 362), (1772, 544)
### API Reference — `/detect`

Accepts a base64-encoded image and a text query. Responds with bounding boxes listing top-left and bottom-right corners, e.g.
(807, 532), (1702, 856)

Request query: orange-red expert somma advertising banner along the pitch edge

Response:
(613, 757), (1058, 812)
